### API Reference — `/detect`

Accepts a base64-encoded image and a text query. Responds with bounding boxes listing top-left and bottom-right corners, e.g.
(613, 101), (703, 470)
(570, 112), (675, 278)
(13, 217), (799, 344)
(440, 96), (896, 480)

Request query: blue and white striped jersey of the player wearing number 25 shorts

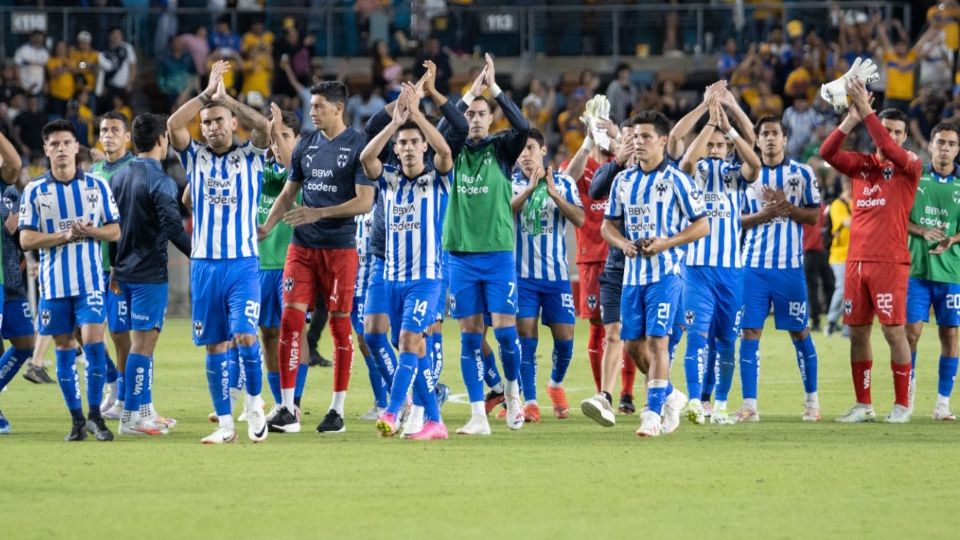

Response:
(19, 170), (120, 300)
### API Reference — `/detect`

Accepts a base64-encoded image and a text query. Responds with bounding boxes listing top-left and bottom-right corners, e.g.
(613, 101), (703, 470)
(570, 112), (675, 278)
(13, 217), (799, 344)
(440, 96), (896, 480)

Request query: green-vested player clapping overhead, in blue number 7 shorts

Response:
(442, 55), (530, 435)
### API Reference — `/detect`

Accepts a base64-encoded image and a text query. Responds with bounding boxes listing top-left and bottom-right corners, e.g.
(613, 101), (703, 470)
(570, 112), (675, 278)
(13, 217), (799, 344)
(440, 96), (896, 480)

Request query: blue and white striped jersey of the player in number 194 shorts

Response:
(743, 159), (820, 270)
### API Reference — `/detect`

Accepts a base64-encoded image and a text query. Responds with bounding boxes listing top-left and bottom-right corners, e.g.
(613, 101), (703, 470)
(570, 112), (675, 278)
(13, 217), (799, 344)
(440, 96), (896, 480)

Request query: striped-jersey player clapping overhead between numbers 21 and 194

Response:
(680, 94), (760, 424)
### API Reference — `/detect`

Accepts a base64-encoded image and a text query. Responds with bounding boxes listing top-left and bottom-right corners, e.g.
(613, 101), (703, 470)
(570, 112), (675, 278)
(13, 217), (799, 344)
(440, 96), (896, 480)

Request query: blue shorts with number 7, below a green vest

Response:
(448, 251), (517, 319)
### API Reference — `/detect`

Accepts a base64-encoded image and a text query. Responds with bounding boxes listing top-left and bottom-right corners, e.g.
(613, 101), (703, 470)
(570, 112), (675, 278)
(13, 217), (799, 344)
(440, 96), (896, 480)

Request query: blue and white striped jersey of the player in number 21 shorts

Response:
(604, 161), (706, 285)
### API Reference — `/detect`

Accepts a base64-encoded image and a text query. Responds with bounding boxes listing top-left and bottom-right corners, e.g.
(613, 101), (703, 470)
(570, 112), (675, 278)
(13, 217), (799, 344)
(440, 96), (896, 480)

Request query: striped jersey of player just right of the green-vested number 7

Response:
(511, 170), (583, 281)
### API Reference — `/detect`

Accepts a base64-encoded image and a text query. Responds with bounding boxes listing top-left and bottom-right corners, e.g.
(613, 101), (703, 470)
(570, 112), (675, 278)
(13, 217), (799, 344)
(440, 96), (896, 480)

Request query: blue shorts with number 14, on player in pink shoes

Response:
(366, 279), (442, 334)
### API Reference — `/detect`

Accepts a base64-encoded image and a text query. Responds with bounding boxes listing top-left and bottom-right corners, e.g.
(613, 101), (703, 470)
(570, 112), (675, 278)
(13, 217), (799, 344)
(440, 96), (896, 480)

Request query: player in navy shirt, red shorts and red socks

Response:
(260, 81), (374, 433)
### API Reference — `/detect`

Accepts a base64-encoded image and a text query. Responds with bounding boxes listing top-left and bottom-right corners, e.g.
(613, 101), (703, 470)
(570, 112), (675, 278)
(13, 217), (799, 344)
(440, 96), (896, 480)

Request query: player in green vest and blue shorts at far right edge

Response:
(907, 122), (960, 421)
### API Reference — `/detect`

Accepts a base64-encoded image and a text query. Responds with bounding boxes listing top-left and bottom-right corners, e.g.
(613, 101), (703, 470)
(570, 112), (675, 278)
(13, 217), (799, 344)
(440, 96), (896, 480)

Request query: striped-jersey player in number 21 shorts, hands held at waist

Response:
(601, 111), (710, 437)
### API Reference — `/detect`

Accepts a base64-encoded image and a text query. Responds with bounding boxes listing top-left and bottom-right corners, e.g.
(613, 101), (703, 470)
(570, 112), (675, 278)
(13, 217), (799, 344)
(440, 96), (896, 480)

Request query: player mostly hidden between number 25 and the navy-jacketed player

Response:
(90, 111), (134, 420)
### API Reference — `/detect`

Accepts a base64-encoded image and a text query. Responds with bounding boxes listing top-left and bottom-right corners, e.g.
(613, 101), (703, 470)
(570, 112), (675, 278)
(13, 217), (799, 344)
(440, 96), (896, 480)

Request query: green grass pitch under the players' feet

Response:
(0, 320), (960, 539)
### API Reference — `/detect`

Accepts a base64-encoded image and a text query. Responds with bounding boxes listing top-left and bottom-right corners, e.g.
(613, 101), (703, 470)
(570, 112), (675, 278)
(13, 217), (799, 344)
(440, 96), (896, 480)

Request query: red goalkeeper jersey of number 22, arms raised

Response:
(820, 113), (923, 264)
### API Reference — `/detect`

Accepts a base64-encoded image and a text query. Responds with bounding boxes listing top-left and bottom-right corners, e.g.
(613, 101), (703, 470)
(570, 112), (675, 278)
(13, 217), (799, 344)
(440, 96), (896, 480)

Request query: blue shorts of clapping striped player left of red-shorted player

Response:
(190, 257), (260, 345)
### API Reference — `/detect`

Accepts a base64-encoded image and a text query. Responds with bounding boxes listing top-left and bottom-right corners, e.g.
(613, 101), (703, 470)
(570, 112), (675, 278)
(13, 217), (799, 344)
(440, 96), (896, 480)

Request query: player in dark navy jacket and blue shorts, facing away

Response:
(110, 114), (190, 435)
